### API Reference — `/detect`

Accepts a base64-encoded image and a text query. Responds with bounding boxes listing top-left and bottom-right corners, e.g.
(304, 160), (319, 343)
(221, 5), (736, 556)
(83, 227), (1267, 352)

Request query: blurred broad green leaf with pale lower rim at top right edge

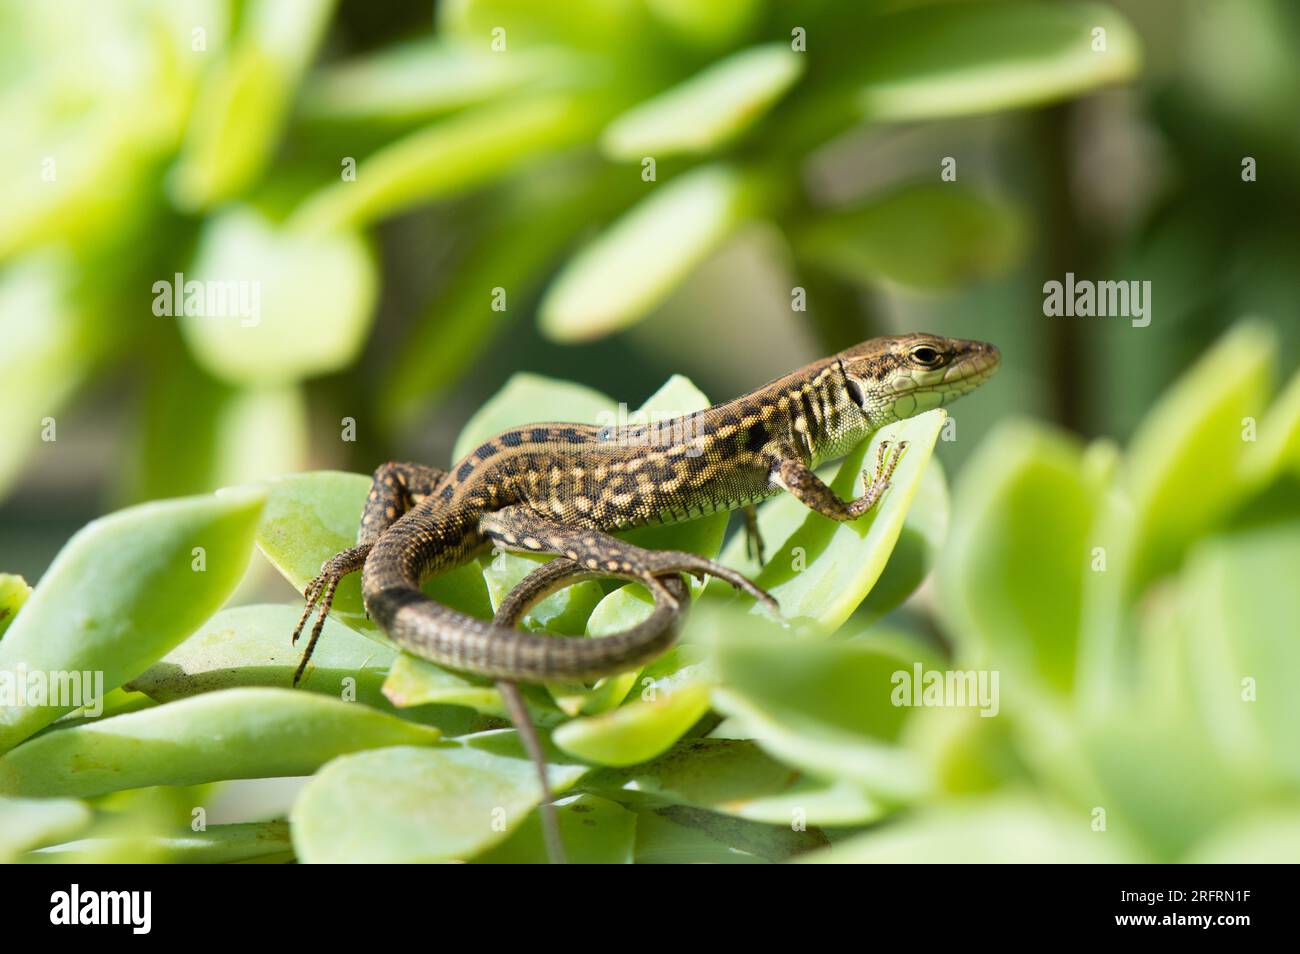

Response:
(852, 3), (1141, 122)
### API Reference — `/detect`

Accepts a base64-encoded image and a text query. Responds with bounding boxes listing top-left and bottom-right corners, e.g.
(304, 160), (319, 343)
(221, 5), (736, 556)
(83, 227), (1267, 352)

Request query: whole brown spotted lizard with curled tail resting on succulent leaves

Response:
(293, 334), (1001, 858)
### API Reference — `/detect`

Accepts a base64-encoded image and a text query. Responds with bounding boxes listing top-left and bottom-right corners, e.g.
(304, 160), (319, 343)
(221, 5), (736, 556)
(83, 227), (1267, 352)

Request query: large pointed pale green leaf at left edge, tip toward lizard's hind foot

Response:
(0, 490), (267, 751)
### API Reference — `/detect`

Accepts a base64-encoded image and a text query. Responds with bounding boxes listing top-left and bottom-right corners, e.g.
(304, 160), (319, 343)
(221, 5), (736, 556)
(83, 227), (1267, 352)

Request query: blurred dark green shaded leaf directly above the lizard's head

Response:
(794, 183), (1024, 289)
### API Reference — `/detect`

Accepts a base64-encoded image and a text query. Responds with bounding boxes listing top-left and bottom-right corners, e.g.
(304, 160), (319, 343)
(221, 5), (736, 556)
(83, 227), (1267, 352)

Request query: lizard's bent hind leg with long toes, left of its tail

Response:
(291, 461), (446, 686)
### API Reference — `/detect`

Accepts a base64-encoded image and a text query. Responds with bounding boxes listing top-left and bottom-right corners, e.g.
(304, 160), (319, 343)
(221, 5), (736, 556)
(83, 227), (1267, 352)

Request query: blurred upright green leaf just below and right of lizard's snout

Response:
(940, 422), (1101, 706)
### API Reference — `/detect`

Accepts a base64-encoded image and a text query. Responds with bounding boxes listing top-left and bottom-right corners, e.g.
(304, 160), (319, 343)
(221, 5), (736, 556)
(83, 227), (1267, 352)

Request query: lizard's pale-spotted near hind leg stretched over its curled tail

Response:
(478, 506), (779, 613)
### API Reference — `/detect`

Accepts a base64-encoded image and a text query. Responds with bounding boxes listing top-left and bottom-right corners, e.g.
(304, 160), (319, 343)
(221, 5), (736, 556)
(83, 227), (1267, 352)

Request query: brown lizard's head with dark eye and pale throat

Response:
(836, 334), (1002, 429)
